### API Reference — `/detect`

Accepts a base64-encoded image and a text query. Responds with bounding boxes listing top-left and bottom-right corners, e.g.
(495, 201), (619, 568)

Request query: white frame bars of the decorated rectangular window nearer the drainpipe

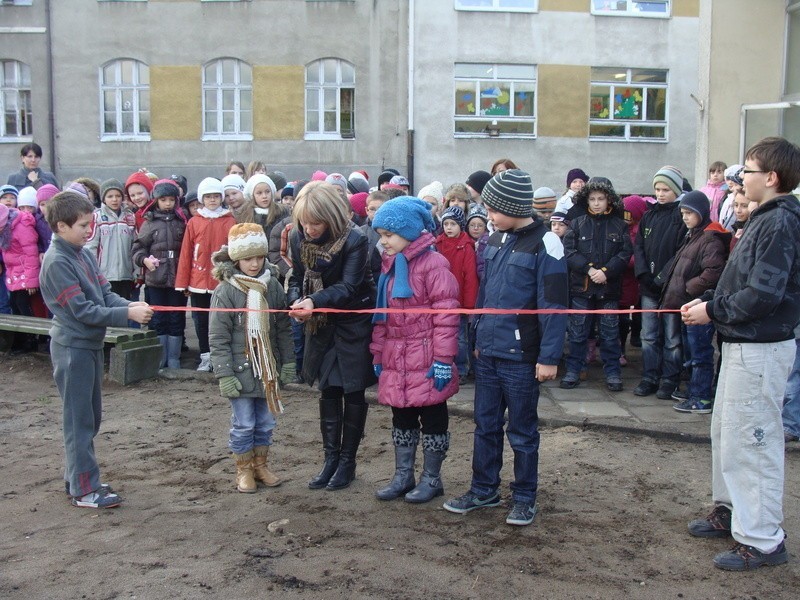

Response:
(451, 63), (539, 139)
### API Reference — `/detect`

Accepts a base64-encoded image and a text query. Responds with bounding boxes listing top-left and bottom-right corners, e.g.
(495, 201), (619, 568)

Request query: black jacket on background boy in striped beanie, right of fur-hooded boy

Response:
(633, 200), (686, 298)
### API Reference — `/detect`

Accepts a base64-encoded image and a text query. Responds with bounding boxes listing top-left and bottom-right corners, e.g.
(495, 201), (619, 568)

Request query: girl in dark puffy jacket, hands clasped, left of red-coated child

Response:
(132, 179), (191, 369)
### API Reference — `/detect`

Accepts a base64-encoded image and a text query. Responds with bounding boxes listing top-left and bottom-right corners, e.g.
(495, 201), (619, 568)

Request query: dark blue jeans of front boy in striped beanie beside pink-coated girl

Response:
(470, 356), (539, 503)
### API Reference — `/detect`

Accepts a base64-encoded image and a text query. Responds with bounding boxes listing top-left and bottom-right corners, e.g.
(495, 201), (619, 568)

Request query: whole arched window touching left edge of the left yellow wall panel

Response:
(100, 58), (150, 141)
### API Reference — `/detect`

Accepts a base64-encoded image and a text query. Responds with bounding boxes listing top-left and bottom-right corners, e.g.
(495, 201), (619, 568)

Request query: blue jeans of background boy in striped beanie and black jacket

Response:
(642, 296), (683, 385)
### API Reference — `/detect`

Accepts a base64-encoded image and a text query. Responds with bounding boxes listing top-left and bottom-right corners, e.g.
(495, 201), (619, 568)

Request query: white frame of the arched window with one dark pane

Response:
(303, 56), (356, 140)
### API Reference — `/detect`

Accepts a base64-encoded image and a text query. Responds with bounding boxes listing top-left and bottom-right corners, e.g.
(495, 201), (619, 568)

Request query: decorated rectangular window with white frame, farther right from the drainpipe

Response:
(589, 67), (669, 141)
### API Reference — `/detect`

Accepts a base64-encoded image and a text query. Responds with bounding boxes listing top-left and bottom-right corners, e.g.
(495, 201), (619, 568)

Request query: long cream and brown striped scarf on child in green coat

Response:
(229, 267), (283, 415)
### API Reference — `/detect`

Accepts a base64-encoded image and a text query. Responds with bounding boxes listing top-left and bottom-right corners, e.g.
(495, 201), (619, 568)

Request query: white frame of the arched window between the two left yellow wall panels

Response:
(202, 56), (254, 142)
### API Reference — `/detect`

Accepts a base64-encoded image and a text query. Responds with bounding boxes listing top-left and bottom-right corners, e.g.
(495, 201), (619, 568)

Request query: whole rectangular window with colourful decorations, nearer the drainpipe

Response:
(455, 63), (536, 137)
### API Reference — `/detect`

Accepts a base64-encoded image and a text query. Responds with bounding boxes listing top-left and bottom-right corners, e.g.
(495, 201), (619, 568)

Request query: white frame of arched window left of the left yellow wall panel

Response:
(98, 58), (151, 142)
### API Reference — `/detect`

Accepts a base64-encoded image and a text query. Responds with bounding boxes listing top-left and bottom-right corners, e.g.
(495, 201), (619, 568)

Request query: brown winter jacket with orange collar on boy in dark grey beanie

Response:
(660, 222), (731, 309)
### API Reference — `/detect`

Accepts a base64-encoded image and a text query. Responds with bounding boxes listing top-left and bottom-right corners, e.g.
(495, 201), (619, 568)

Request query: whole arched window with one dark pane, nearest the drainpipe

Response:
(306, 58), (356, 140)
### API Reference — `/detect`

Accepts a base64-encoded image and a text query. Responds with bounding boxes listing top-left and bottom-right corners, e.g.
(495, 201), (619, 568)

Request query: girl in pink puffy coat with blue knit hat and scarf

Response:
(370, 196), (459, 503)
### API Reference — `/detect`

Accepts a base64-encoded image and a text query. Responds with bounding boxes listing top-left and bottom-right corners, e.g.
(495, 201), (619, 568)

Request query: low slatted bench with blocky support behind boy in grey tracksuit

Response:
(0, 315), (162, 385)
